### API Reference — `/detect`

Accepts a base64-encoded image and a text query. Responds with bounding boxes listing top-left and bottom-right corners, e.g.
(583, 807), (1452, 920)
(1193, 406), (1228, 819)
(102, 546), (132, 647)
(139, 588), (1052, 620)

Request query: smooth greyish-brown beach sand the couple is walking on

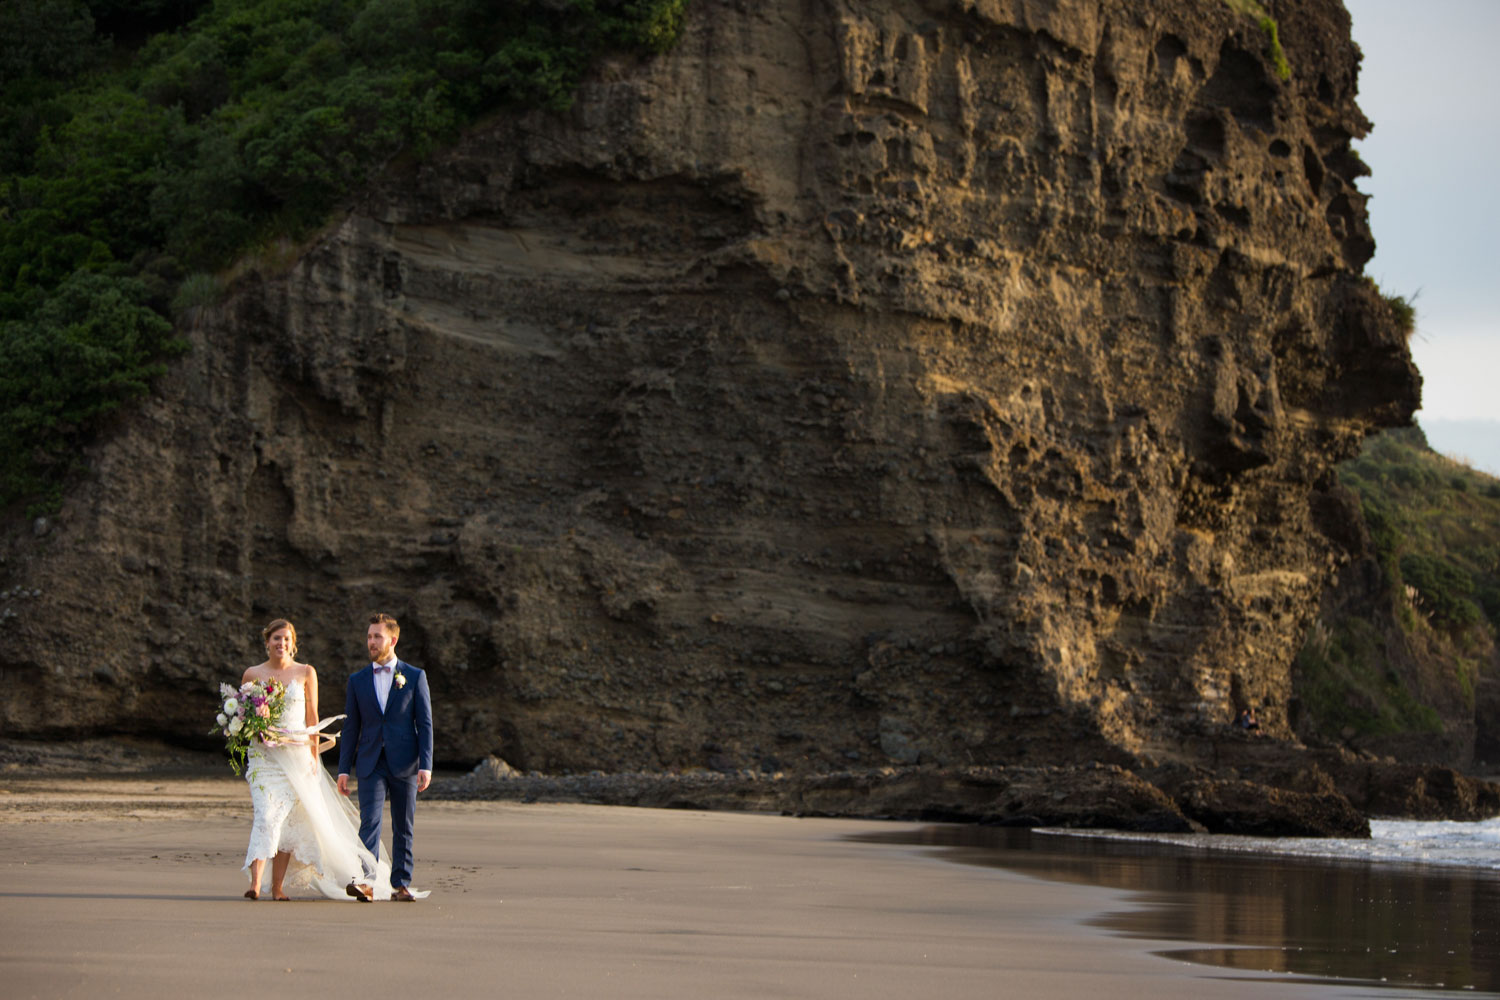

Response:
(0, 775), (1400, 1000)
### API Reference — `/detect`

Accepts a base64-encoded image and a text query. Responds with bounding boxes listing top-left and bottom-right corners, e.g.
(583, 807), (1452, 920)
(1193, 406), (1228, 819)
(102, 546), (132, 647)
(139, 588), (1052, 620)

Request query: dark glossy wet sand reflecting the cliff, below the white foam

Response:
(863, 826), (1500, 994)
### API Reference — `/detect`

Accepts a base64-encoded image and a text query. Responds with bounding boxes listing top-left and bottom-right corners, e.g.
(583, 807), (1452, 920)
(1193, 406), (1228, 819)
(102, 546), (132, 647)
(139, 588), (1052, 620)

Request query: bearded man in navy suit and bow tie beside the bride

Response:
(339, 615), (432, 903)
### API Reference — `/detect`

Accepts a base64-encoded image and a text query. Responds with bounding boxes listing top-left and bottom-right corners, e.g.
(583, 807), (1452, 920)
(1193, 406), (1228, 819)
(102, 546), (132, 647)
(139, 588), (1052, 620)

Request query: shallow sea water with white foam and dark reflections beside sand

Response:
(875, 820), (1500, 997)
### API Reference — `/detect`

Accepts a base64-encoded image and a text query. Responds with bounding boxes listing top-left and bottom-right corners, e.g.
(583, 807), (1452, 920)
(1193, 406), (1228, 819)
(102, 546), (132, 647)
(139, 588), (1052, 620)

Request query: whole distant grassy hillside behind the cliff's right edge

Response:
(1298, 427), (1500, 768)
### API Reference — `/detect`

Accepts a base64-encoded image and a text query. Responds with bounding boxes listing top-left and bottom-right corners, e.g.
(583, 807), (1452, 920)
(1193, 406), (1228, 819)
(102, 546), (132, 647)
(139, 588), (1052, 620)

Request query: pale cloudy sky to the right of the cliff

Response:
(1344, 0), (1500, 474)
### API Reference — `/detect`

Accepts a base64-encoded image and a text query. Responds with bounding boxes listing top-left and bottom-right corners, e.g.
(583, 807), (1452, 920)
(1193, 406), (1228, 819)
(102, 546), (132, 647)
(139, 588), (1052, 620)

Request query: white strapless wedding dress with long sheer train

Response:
(245, 681), (390, 903)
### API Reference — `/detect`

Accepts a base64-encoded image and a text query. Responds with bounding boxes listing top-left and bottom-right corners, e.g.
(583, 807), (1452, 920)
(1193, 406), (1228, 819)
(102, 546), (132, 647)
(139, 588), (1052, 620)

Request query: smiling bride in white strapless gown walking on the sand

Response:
(240, 618), (390, 900)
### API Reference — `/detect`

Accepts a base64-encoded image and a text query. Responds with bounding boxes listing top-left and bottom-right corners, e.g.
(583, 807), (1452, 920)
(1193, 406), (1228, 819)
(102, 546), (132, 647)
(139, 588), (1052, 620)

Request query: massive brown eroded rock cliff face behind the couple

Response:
(0, 0), (1419, 771)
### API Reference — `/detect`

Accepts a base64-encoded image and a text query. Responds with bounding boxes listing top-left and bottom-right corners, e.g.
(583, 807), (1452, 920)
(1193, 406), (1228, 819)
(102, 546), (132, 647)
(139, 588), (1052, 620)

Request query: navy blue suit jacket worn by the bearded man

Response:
(339, 660), (432, 778)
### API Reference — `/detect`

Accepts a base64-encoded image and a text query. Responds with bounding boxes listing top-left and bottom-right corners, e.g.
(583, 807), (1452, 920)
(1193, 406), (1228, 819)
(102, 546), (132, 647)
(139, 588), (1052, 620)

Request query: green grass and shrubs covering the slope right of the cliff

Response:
(1298, 427), (1500, 735)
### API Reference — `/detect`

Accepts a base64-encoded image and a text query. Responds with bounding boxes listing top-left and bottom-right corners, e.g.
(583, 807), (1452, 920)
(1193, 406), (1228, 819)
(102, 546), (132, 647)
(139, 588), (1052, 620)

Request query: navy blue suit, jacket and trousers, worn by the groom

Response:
(339, 660), (432, 889)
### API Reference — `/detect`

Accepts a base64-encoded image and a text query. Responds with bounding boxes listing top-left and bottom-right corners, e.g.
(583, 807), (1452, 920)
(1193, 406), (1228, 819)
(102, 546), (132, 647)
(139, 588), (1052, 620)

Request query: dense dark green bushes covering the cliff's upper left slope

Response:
(0, 0), (690, 507)
